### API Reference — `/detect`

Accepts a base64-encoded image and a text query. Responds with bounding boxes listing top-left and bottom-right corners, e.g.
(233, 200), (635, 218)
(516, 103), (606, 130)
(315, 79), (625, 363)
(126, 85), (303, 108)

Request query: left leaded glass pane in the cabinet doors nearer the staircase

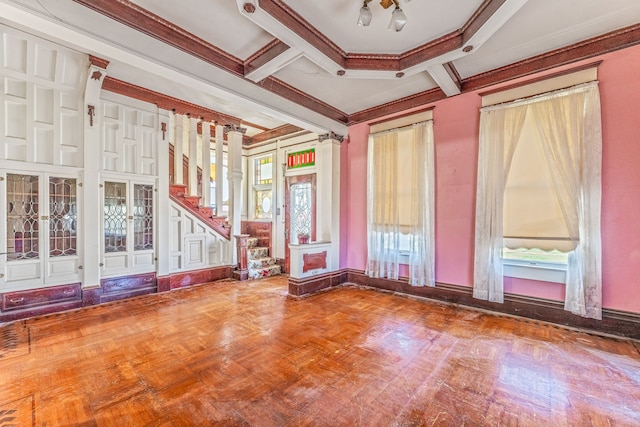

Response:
(104, 182), (127, 252)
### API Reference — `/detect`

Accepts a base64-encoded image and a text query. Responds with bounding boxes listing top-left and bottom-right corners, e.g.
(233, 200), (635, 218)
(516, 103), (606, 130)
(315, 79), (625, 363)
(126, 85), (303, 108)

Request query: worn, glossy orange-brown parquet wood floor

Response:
(0, 277), (640, 427)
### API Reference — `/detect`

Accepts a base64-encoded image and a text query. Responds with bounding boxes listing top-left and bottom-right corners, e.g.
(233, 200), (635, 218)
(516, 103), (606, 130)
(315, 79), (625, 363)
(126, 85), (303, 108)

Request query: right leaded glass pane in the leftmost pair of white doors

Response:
(49, 177), (78, 257)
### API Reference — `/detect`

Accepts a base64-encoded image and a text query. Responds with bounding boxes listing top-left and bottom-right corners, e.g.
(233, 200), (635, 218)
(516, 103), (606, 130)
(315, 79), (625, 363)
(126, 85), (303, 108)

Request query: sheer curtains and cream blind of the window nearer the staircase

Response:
(366, 121), (435, 286)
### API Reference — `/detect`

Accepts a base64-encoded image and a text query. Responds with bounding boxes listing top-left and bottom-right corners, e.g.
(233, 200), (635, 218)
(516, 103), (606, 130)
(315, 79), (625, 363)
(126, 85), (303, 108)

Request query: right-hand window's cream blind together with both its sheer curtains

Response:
(474, 82), (602, 318)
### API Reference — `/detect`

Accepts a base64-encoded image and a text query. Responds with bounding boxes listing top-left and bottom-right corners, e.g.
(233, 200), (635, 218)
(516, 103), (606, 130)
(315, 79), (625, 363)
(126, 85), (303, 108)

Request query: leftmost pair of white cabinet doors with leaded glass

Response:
(0, 171), (82, 289)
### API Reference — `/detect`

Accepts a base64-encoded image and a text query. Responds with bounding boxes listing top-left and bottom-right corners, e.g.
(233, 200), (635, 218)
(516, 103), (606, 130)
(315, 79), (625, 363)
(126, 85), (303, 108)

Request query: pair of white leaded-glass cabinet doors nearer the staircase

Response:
(100, 180), (155, 277)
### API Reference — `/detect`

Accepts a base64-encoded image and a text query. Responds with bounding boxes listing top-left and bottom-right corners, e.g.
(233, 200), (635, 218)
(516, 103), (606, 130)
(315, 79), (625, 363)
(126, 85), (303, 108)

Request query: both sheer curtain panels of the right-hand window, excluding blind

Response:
(474, 82), (602, 319)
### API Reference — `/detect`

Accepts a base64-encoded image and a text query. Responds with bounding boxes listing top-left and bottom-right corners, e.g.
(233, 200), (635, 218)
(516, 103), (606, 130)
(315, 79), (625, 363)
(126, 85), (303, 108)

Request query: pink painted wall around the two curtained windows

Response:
(341, 46), (640, 313)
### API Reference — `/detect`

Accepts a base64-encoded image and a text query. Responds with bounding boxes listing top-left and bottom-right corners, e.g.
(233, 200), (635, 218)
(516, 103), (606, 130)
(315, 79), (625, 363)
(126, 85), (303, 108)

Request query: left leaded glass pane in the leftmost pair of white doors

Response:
(7, 174), (39, 261)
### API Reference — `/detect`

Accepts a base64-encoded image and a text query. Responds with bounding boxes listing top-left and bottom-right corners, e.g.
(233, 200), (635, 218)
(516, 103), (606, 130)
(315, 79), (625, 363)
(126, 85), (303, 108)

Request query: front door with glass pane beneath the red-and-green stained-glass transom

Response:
(284, 174), (316, 272)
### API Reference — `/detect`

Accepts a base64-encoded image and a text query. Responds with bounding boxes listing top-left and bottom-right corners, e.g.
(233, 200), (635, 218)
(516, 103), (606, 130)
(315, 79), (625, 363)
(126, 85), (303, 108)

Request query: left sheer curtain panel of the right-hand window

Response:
(473, 106), (527, 303)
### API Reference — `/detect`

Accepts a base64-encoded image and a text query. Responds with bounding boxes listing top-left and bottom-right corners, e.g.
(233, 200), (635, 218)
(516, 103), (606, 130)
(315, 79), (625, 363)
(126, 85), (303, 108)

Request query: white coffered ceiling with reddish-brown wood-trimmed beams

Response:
(0, 0), (640, 140)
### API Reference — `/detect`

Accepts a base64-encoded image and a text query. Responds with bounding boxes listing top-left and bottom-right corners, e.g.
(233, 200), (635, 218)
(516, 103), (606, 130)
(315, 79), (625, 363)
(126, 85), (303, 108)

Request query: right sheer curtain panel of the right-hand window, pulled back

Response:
(531, 82), (602, 319)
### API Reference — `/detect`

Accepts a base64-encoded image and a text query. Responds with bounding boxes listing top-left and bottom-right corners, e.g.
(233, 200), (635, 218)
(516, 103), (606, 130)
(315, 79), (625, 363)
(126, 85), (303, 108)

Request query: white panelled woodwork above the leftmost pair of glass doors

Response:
(0, 25), (88, 167)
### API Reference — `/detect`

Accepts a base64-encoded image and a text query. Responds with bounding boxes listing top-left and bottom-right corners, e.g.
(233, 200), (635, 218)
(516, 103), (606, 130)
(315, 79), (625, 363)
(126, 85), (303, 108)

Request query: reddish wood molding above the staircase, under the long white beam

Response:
(102, 76), (241, 126)
